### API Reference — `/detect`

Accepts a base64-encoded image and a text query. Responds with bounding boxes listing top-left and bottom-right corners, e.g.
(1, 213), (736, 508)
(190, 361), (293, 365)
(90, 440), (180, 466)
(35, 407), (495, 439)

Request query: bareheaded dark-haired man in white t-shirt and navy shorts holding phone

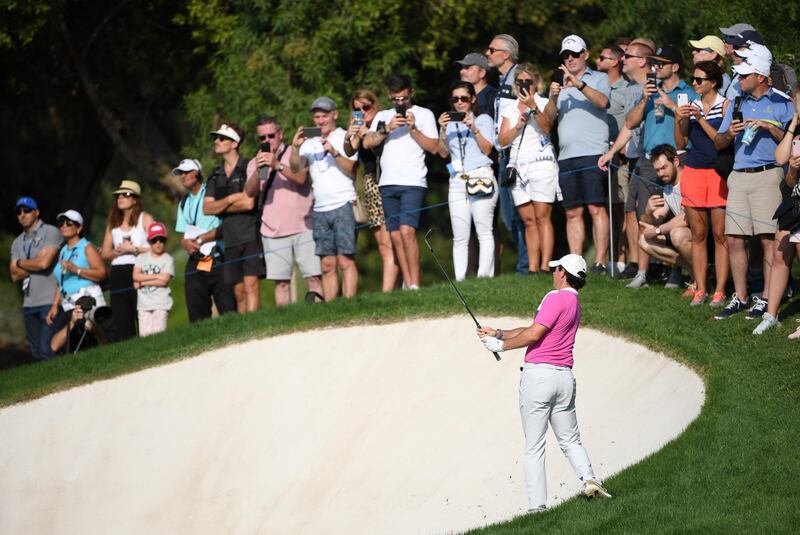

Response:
(364, 75), (439, 290)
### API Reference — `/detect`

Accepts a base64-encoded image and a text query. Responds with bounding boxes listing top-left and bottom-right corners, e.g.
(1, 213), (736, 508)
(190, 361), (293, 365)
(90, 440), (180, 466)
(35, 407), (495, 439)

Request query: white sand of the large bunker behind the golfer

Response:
(0, 316), (704, 534)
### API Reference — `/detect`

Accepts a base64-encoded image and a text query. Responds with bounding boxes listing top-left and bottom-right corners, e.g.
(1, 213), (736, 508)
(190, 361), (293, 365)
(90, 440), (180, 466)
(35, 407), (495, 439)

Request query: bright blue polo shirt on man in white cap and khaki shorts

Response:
(719, 88), (794, 170)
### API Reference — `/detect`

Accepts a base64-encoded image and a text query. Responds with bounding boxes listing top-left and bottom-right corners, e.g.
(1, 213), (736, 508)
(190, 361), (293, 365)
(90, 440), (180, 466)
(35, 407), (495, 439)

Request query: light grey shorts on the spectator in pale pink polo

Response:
(261, 230), (322, 281)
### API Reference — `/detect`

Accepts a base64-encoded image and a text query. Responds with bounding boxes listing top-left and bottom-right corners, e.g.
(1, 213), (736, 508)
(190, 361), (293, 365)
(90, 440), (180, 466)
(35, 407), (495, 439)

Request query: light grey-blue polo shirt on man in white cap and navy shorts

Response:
(556, 68), (611, 160)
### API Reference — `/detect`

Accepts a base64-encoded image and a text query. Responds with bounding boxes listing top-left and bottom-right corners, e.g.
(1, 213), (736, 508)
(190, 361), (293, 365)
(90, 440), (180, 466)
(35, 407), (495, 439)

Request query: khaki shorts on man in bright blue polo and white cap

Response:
(725, 167), (783, 236)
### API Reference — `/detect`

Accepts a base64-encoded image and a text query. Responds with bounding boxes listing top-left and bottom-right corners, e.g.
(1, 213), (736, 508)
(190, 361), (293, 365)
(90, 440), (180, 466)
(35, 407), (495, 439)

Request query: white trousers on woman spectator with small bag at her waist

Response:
(447, 167), (499, 280)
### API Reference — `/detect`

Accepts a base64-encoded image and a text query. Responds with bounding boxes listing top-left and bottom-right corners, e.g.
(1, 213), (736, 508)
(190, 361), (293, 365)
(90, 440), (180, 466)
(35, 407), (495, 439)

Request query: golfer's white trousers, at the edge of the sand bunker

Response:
(519, 364), (597, 509)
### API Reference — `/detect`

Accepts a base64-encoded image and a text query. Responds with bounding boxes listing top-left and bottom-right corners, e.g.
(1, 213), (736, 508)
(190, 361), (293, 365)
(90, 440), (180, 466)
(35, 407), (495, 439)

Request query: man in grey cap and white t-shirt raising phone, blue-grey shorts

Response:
(286, 97), (358, 301)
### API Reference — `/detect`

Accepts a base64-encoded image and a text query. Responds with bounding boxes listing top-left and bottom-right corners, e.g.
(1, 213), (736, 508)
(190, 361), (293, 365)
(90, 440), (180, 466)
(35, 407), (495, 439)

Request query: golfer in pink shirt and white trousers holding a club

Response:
(478, 254), (611, 513)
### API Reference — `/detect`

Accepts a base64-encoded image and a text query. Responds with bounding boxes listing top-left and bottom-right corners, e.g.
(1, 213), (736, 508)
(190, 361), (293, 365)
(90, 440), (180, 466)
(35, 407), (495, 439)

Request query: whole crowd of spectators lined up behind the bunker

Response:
(10, 23), (800, 359)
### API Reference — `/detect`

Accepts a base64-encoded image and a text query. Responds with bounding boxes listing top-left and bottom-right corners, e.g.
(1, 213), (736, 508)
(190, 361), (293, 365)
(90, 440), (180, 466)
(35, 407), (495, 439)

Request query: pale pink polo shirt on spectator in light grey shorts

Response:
(247, 145), (314, 238)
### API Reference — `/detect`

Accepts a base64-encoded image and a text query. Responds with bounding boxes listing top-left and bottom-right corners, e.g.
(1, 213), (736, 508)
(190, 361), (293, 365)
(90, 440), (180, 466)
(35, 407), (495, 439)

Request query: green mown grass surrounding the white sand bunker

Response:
(0, 275), (800, 534)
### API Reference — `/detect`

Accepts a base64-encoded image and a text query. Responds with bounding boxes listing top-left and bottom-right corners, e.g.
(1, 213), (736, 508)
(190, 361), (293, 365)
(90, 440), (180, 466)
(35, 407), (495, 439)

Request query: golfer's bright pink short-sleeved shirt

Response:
(525, 288), (581, 368)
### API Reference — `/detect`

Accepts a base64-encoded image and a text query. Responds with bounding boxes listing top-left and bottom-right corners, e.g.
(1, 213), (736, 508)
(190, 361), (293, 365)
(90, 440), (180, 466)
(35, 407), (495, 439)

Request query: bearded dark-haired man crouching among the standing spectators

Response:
(639, 144), (692, 286)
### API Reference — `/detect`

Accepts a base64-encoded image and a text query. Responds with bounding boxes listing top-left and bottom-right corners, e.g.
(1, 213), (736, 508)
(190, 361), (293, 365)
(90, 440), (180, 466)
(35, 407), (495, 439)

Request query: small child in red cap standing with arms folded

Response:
(133, 221), (175, 336)
